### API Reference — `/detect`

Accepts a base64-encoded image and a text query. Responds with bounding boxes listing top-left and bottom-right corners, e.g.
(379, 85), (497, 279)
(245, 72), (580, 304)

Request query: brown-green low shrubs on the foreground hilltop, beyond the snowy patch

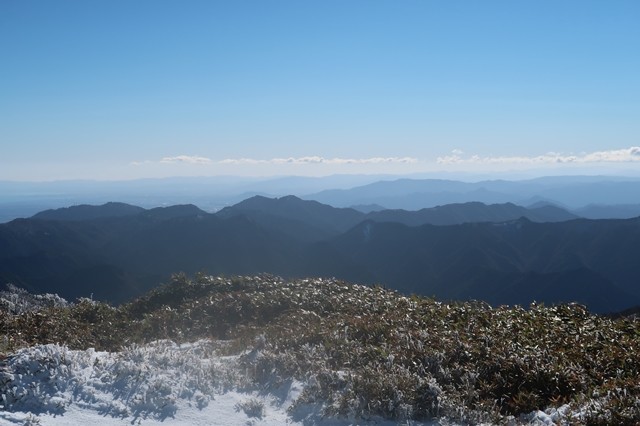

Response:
(0, 275), (640, 424)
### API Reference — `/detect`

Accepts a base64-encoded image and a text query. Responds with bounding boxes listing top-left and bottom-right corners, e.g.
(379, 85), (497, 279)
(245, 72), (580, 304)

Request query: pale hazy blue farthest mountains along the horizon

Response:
(0, 175), (640, 223)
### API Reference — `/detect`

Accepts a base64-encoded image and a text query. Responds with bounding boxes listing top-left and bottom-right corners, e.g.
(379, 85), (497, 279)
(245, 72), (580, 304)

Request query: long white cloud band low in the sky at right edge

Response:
(437, 146), (640, 165)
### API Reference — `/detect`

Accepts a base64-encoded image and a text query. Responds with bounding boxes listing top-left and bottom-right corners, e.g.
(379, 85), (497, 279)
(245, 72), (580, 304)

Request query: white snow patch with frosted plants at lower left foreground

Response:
(0, 340), (563, 426)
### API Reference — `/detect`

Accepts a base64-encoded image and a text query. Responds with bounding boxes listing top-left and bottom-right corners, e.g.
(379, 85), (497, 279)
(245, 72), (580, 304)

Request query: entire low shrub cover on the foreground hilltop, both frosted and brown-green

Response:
(0, 274), (640, 425)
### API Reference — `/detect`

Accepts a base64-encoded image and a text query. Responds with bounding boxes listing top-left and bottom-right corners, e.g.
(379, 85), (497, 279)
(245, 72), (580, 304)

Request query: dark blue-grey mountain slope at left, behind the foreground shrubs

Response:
(0, 206), (297, 302)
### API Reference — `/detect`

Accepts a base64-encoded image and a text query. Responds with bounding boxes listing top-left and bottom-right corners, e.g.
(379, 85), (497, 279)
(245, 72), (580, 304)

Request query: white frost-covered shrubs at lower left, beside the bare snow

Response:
(0, 341), (243, 420)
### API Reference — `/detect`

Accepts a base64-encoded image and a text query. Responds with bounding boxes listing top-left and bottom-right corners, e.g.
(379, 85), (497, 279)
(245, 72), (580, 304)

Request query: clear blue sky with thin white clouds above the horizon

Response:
(0, 0), (640, 180)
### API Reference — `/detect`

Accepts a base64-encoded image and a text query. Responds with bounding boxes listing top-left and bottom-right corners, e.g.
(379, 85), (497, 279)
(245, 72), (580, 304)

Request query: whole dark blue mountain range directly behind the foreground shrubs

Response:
(0, 196), (640, 312)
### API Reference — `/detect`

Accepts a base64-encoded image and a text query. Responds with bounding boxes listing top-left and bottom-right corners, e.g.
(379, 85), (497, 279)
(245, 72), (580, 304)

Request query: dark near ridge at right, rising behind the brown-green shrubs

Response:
(306, 219), (640, 312)
